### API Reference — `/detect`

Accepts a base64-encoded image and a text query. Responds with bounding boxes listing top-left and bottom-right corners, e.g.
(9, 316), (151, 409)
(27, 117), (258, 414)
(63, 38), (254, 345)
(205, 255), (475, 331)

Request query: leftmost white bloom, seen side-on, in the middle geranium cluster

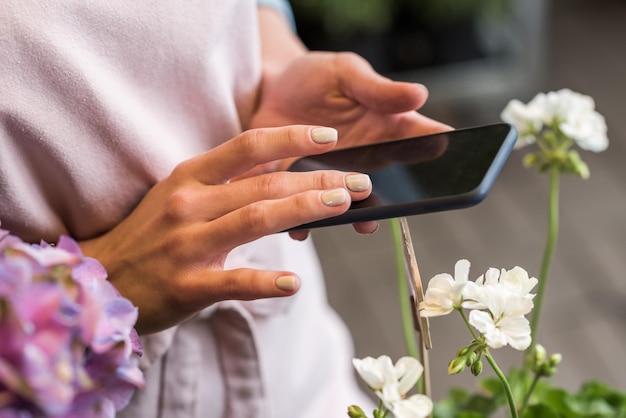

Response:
(419, 260), (470, 317)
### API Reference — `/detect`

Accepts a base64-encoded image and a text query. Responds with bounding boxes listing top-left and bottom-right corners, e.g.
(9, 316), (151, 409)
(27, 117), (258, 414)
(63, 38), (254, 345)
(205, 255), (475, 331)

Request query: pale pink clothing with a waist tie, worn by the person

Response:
(0, 0), (364, 418)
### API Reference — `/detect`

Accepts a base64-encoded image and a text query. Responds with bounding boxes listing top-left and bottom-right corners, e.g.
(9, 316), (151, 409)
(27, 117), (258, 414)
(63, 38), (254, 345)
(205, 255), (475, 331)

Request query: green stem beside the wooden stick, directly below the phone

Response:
(391, 219), (423, 361)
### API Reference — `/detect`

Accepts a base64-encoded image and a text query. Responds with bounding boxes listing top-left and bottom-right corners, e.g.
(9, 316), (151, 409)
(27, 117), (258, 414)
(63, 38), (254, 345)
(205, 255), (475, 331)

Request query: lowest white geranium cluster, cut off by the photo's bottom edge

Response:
(348, 355), (433, 418)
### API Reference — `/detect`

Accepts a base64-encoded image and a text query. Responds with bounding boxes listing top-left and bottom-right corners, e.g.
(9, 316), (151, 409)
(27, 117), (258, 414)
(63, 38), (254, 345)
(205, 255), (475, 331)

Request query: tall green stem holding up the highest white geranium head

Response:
(527, 167), (560, 344)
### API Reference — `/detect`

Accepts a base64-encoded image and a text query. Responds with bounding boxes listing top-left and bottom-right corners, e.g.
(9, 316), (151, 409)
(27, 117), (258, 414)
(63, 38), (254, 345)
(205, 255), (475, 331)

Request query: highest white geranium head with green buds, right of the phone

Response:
(500, 89), (609, 178)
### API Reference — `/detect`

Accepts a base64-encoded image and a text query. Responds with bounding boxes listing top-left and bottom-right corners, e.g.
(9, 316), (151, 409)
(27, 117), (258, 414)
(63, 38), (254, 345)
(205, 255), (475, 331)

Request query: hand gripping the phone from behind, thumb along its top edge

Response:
(250, 52), (451, 152)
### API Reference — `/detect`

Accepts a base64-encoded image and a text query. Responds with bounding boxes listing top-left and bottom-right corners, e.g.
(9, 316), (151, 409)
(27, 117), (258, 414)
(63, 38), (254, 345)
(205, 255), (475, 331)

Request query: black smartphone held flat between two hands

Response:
(288, 123), (517, 230)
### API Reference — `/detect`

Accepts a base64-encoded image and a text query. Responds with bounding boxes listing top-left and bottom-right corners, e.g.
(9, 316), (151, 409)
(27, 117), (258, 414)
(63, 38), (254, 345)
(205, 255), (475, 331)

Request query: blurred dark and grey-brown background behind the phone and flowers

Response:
(291, 0), (626, 399)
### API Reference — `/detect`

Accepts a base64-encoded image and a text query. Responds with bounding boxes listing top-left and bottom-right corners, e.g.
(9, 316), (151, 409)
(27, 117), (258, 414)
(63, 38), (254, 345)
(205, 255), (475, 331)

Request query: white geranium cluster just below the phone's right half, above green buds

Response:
(419, 260), (537, 350)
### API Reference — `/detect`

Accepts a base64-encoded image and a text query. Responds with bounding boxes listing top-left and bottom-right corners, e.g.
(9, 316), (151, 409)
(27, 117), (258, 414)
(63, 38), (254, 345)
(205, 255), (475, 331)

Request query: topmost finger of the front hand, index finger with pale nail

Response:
(181, 125), (337, 184)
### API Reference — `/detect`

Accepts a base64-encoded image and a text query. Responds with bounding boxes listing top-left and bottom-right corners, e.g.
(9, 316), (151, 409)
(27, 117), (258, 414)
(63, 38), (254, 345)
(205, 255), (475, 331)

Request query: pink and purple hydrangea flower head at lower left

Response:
(0, 229), (144, 418)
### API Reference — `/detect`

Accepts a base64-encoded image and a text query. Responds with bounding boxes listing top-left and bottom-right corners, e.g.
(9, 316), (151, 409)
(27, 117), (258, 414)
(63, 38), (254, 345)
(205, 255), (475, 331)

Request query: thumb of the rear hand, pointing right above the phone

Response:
(335, 53), (428, 114)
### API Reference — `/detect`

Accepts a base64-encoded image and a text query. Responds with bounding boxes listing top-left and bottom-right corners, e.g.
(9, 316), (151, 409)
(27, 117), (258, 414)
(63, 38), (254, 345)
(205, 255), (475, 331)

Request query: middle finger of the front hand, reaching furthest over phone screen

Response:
(206, 170), (372, 218)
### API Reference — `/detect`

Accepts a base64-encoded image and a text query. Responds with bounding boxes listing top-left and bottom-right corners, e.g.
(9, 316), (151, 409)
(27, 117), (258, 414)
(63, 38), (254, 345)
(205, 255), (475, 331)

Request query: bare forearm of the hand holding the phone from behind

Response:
(258, 7), (307, 77)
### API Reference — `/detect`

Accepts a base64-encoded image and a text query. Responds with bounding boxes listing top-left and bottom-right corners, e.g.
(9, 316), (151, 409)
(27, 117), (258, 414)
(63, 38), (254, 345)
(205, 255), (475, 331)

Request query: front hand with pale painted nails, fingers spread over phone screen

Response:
(81, 126), (371, 333)
